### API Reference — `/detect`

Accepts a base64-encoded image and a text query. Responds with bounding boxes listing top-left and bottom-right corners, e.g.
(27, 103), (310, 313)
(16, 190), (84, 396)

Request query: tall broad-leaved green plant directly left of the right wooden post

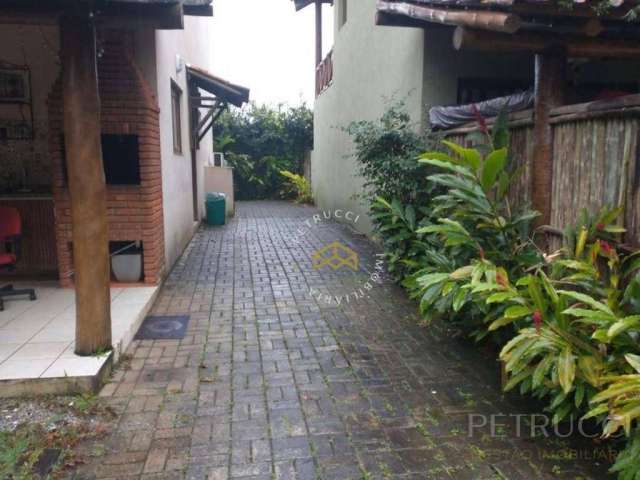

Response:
(405, 135), (542, 330)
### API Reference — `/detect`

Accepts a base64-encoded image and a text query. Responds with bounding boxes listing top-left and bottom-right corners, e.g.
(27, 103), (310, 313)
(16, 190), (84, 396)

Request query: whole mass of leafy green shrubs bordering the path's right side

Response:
(362, 118), (640, 480)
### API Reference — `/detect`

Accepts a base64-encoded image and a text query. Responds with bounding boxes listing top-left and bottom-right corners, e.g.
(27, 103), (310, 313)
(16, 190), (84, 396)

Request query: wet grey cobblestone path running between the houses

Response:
(76, 202), (606, 480)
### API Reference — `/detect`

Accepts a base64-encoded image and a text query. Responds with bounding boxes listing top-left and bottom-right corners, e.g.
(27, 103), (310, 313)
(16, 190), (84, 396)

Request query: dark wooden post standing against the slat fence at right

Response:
(531, 48), (567, 225)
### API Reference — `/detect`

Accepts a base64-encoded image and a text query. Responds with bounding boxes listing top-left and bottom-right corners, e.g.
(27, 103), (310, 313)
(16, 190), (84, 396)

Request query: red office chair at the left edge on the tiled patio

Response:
(0, 207), (36, 311)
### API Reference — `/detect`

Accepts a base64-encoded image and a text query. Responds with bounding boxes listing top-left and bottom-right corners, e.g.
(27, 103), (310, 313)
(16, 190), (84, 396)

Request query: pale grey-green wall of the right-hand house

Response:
(309, 0), (424, 233)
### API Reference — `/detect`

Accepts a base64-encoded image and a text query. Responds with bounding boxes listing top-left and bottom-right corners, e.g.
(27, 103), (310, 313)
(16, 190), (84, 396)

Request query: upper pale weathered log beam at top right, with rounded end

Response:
(377, 0), (522, 33)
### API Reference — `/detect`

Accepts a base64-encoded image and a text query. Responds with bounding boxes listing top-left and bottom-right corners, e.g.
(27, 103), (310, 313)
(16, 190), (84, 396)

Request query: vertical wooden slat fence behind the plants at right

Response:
(445, 103), (640, 246)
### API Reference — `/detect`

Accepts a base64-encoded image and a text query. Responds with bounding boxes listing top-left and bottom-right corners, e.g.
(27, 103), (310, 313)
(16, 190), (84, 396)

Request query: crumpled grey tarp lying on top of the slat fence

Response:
(429, 90), (534, 129)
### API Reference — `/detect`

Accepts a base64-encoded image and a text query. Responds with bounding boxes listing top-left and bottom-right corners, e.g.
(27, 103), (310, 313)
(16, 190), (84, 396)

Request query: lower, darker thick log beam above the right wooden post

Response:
(453, 27), (640, 59)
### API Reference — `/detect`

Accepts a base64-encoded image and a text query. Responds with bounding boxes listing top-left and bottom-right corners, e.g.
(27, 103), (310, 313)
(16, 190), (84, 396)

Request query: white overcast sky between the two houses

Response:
(212, 0), (333, 106)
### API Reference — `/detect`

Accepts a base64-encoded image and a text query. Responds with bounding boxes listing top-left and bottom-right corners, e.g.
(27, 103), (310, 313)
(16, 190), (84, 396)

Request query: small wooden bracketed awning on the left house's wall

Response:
(187, 65), (249, 149)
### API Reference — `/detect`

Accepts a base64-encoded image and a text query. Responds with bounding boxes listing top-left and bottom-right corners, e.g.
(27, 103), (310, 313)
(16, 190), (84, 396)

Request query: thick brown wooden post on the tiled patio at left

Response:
(60, 11), (111, 355)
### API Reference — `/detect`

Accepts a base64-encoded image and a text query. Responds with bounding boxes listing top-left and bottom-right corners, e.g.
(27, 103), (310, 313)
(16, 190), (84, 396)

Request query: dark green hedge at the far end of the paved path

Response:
(214, 104), (313, 200)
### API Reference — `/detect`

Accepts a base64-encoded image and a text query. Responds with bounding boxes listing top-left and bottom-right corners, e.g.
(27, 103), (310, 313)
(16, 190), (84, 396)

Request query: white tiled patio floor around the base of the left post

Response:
(0, 282), (158, 381)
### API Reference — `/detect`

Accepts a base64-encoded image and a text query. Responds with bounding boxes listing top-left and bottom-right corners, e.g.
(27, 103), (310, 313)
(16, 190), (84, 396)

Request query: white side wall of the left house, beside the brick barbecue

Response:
(156, 16), (213, 270)
